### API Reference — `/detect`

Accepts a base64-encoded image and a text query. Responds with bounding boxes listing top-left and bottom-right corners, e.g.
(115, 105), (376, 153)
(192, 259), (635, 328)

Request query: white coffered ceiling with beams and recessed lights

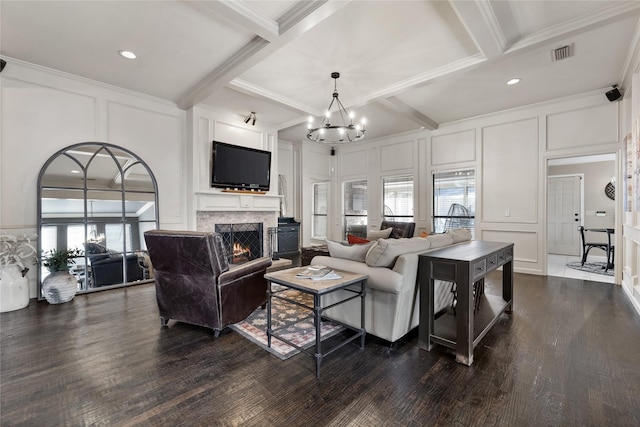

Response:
(0, 0), (640, 141)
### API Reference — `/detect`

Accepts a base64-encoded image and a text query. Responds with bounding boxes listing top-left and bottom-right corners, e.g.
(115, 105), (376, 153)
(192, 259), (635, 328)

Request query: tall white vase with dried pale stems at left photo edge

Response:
(0, 230), (37, 313)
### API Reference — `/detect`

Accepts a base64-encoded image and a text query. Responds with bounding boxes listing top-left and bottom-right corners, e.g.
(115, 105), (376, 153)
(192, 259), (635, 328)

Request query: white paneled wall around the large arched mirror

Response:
(0, 60), (187, 297)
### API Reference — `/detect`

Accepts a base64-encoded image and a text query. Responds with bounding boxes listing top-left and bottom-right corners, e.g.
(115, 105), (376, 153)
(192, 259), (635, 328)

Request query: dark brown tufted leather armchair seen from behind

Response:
(144, 230), (271, 337)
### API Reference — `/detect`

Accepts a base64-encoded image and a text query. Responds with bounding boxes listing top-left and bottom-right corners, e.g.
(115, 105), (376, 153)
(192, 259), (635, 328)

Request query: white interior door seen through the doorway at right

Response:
(547, 175), (582, 256)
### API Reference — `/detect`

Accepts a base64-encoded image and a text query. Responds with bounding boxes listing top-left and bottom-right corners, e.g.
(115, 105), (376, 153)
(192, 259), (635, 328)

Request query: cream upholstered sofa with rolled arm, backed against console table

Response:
(312, 229), (471, 342)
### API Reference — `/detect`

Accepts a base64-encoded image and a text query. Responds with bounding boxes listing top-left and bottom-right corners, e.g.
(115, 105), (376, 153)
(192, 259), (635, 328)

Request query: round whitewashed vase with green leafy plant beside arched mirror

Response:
(42, 248), (83, 304)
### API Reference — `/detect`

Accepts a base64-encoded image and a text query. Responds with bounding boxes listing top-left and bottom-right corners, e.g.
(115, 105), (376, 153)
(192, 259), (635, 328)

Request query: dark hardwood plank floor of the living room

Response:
(0, 273), (640, 426)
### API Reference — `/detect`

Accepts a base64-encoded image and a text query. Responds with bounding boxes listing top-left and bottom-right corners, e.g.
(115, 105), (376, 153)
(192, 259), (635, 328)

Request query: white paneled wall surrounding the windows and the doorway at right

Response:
(300, 91), (620, 282)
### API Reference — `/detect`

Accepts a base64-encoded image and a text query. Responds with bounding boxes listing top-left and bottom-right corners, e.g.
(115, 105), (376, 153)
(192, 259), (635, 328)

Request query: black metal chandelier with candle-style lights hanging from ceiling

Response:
(307, 72), (366, 143)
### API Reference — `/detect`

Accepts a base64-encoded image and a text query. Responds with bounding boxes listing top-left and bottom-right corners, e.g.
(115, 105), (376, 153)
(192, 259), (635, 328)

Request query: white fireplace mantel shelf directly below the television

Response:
(195, 190), (282, 212)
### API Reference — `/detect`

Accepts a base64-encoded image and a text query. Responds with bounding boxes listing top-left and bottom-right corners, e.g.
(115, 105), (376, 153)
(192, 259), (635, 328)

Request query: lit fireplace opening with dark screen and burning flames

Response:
(215, 222), (263, 264)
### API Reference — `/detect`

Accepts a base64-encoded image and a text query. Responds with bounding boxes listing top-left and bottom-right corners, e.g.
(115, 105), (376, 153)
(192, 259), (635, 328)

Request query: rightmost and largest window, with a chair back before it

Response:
(433, 170), (476, 233)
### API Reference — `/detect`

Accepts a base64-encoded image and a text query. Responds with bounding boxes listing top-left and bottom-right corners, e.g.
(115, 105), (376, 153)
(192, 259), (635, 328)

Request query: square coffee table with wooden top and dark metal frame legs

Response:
(264, 267), (368, 378)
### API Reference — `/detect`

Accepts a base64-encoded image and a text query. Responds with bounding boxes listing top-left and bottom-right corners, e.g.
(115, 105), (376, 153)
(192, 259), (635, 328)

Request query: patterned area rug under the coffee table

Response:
(230, 289), (344, 360)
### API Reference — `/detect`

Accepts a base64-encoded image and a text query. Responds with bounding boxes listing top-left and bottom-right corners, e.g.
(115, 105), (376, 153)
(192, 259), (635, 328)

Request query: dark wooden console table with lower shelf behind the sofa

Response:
(418, 240), (513, 366)
